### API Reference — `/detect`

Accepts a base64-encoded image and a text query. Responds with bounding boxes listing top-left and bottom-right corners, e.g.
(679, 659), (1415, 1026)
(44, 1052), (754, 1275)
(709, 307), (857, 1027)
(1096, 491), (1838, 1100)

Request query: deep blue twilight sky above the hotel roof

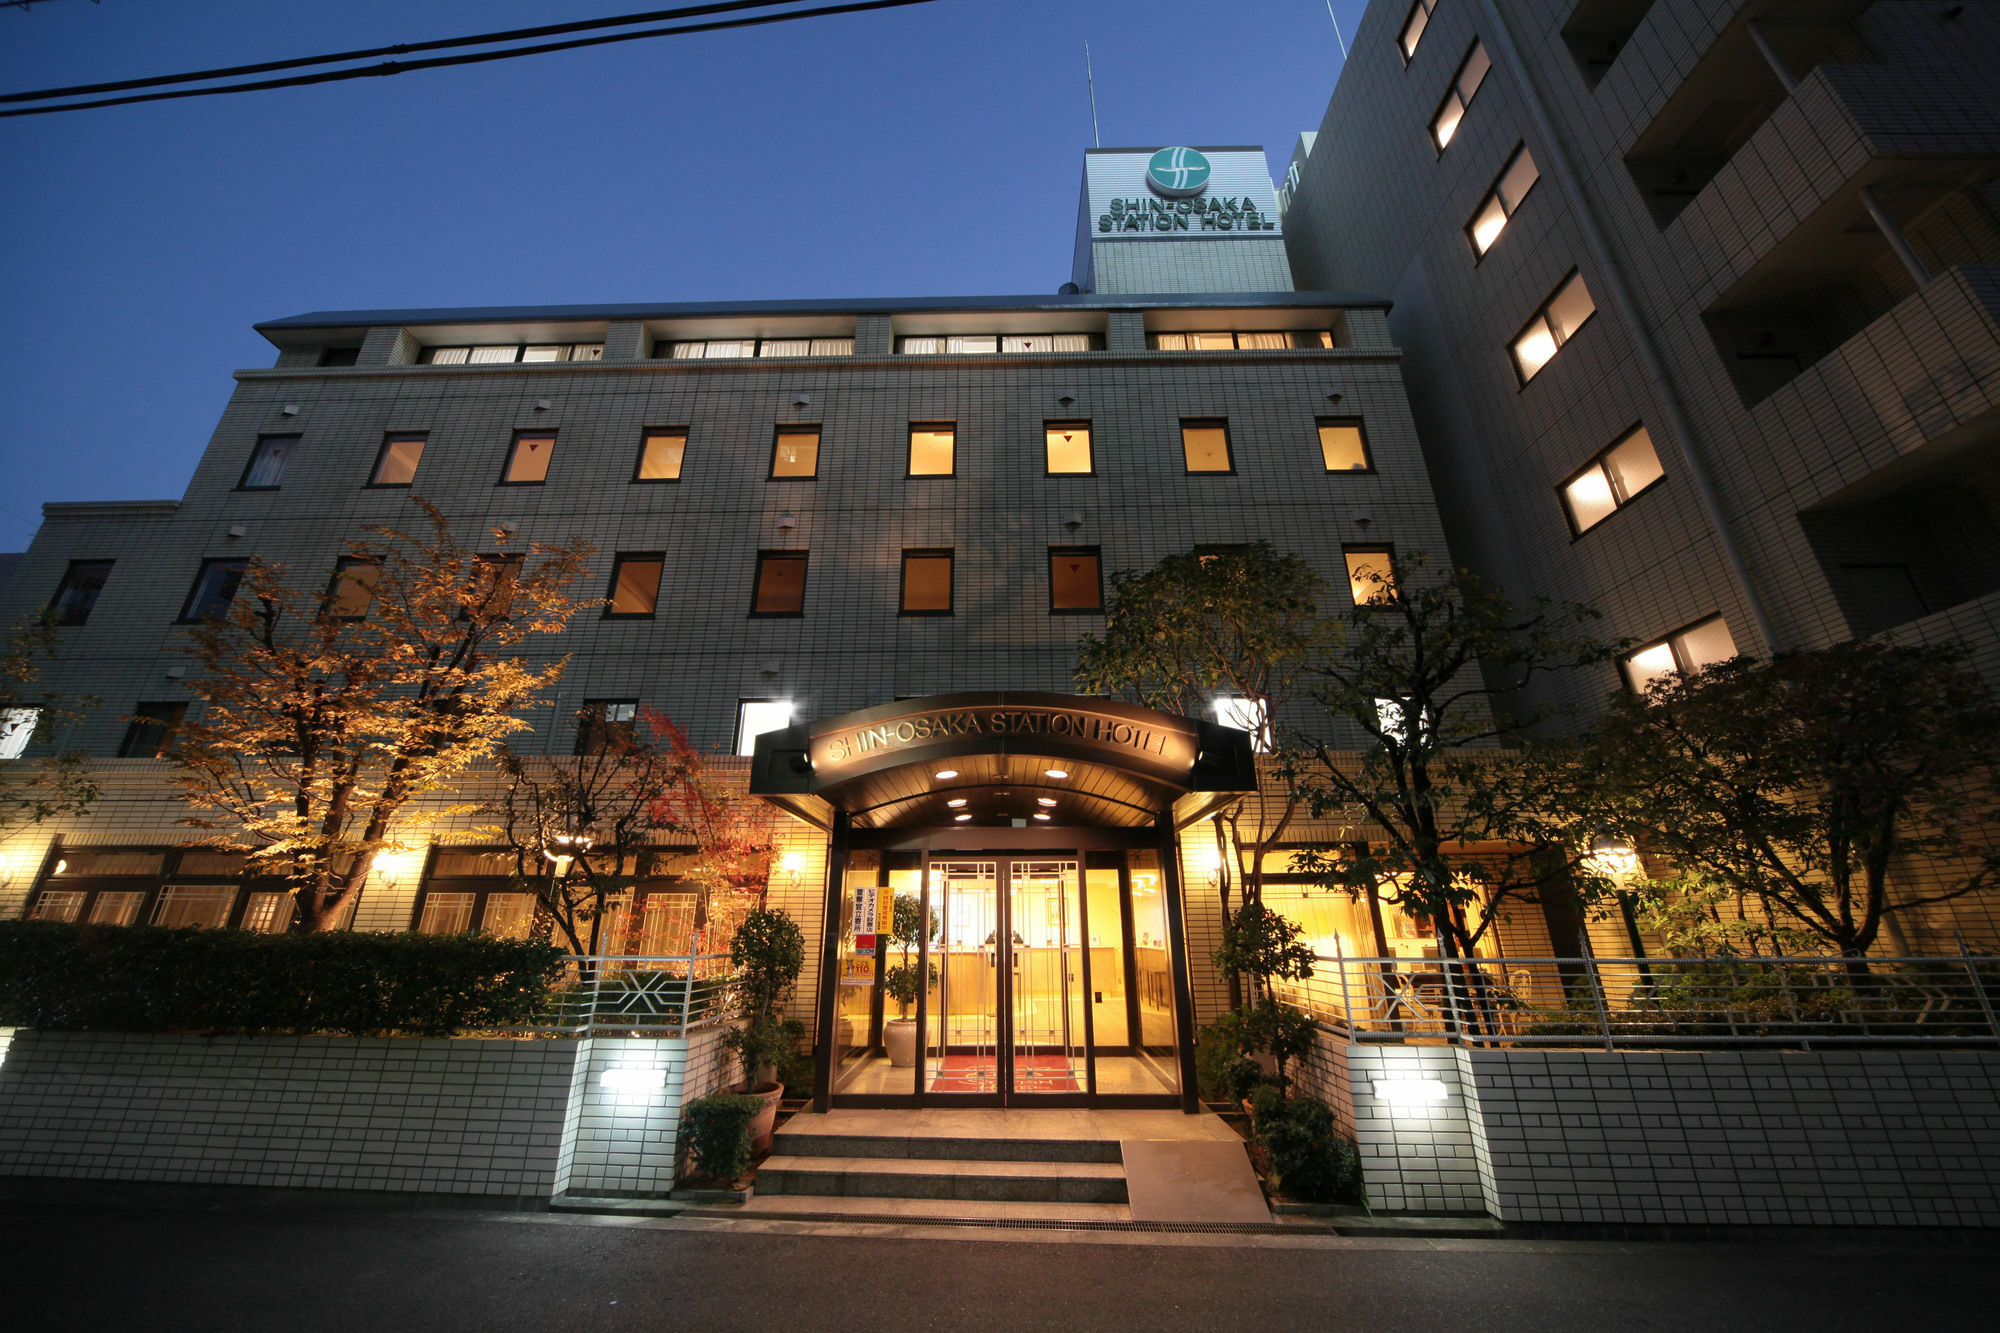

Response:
(0, 0), (1364, 550)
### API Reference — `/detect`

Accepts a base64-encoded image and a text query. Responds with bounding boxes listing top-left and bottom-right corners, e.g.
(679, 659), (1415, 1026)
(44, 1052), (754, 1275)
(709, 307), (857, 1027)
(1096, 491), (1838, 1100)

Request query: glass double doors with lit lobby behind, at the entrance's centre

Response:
(922, 857), (1090, 1105)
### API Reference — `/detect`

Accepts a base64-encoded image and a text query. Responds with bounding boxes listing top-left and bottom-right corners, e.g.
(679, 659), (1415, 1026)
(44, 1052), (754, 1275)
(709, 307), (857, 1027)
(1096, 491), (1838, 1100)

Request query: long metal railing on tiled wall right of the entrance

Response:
(1274, 955), (2000, 1051)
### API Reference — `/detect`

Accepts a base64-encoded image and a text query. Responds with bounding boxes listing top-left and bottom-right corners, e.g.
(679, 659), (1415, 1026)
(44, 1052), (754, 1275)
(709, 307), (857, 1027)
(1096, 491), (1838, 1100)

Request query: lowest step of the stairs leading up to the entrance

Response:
(756, 1143), (1126, 1203)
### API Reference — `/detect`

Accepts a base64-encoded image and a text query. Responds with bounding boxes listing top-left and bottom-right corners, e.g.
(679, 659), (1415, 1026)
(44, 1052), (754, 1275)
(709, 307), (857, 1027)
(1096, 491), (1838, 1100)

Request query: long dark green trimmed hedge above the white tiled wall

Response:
(0, 921), (566, 1037)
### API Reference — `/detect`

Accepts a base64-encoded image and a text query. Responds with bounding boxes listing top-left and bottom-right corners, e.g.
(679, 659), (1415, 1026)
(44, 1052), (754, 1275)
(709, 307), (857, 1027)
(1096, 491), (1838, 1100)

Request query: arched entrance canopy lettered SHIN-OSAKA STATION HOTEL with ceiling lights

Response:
(750, 691), (1256, 829)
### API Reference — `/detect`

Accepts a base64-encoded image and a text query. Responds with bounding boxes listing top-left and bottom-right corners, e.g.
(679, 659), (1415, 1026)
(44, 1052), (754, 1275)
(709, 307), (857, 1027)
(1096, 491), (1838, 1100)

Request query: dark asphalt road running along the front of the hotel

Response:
(0, 1187), (2000, 1333)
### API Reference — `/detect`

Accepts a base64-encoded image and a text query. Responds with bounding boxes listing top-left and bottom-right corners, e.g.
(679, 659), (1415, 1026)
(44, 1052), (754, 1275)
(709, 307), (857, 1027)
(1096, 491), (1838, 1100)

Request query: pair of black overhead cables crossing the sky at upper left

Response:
(0, 0), (934, 118)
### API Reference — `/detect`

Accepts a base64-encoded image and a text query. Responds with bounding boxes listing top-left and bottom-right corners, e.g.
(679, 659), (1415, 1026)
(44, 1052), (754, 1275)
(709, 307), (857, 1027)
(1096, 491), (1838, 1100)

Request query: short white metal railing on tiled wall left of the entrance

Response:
(514, 955), (736, 1037)
